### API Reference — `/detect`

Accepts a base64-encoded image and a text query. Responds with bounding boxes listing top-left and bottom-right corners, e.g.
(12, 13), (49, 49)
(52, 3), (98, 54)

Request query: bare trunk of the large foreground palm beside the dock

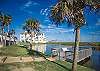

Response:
(72, 27), (80, 71)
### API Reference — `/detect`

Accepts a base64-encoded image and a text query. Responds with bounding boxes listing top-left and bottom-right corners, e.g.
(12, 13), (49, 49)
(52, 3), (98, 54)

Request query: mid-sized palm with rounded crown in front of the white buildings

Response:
(23, 18), (40, 41)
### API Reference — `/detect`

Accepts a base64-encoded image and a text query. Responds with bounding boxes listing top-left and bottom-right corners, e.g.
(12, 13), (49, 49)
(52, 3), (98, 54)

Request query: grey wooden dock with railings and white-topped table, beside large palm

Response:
(51, 48), (92, 62)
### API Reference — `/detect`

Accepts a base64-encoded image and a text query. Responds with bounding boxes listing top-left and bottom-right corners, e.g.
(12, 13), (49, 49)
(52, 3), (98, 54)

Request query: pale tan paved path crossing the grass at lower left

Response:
(0, 56), (45, 63)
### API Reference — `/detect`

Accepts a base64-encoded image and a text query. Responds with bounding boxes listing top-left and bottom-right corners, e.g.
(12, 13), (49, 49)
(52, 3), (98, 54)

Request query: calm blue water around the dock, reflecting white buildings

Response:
(32, 44), (100, 71)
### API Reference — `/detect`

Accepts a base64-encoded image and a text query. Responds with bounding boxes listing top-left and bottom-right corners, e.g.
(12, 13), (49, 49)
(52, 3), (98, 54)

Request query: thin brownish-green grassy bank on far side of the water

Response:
(47, 42), (100, 46)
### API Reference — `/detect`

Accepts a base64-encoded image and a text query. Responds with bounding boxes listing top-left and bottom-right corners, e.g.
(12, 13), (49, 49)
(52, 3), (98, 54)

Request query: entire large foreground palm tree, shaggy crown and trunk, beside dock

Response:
(50, 0), (100, 71)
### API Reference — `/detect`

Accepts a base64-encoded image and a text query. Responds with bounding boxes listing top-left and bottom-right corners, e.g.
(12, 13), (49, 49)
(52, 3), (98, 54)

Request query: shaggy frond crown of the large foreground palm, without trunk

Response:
(49, 0), (100, 27)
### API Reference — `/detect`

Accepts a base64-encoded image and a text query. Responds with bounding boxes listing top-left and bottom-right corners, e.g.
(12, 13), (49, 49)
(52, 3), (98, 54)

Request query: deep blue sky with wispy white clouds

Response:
(0, 0), (100, 42)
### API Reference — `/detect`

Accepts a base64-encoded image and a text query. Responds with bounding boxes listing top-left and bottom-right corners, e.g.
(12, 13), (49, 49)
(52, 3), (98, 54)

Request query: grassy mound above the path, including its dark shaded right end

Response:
(0, 45), (46, 57)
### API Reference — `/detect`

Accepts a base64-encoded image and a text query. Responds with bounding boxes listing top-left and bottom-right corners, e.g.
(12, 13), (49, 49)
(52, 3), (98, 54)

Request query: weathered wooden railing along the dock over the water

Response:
(52, 48), (92, 62)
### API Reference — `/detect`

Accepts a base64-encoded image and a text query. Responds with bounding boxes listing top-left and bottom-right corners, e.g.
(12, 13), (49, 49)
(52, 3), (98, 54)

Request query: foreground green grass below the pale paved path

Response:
(0, 61), (94, 71)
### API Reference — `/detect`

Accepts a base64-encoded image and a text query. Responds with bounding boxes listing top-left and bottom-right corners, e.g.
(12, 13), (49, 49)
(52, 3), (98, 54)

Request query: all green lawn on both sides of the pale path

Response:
(0, 45), (94, 71)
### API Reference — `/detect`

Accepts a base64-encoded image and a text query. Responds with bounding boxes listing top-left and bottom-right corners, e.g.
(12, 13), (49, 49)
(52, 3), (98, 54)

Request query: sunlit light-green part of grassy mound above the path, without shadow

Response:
(0, 45), (29, 56)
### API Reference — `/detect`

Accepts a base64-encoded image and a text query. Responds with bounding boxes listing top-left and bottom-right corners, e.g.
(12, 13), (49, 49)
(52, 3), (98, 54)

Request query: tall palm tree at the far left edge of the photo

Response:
(0, 12), (12, 45)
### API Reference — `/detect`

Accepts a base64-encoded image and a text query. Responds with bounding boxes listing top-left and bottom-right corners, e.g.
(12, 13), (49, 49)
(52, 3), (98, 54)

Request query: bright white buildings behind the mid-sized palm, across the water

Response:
(20, 32), (47, 43)
